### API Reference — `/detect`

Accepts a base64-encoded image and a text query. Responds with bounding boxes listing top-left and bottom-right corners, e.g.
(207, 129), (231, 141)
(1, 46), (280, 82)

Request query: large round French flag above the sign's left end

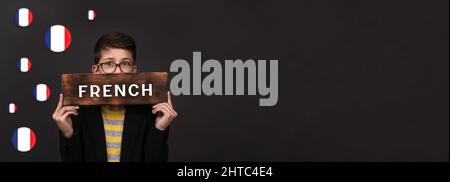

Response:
(45, 25), (72, 52)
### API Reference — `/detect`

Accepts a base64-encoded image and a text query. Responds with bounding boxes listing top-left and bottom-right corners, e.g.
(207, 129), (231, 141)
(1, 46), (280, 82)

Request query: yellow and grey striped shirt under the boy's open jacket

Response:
(102, 107), (125, 162)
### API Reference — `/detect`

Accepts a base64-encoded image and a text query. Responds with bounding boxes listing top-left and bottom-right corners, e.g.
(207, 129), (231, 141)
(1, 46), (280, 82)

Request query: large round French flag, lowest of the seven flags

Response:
(11, 127), (36, 152)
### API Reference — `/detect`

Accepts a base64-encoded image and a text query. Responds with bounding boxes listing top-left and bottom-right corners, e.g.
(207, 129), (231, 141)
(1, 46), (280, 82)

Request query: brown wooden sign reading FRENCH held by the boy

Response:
(61, 72), (168, 106)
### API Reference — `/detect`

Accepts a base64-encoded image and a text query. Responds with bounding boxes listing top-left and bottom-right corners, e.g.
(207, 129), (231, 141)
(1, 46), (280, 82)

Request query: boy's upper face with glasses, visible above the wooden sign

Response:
(92, 48), (137, 74)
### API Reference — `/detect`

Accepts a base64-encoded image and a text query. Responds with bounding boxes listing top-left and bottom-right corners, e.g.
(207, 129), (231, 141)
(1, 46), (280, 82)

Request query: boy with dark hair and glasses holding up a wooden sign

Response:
(53, 32), (177, 162)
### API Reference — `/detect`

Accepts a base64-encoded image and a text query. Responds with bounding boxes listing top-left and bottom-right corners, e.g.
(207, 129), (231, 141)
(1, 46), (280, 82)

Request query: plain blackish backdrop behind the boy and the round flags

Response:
(0, 0), (449, 161)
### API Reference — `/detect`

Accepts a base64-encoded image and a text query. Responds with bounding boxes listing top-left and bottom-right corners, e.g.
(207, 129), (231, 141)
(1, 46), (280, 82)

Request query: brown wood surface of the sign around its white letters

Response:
(61, 72), (168, 106)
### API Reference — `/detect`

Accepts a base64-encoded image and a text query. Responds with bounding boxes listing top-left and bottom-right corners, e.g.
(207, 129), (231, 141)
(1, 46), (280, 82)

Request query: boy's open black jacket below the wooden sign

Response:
(59, 105), (169, 162)
